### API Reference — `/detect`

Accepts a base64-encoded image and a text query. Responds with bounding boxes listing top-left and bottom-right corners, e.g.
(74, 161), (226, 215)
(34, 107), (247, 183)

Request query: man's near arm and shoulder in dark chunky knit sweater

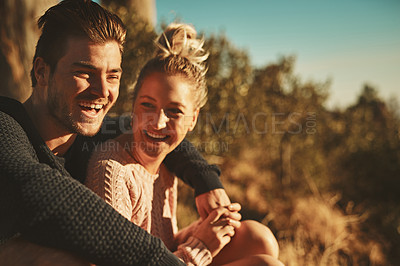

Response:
(0, 97), (219, 265)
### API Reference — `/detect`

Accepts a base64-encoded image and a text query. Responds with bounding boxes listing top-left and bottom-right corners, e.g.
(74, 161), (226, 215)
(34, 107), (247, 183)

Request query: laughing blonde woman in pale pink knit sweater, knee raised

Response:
(86, 24), (280, 265)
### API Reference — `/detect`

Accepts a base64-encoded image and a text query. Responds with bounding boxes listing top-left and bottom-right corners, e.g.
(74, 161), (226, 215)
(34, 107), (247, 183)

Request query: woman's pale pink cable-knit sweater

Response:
(86, 138), (212, 265)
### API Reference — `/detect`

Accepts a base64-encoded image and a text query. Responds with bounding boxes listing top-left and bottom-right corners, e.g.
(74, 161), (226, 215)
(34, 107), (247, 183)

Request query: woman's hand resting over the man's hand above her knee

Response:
(193, 206), (241, 257)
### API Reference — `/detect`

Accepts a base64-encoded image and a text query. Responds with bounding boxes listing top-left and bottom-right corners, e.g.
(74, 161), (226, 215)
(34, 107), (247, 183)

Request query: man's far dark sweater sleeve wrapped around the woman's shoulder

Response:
(164, 139), (223, 196)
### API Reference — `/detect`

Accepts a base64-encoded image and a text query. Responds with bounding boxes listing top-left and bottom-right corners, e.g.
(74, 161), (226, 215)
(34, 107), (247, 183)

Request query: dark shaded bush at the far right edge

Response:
(332, 85), (400, 262)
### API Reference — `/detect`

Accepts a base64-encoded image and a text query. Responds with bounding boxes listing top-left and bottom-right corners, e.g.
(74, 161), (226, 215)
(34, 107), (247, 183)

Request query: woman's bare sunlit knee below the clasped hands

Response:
(240, 220), (279, 258)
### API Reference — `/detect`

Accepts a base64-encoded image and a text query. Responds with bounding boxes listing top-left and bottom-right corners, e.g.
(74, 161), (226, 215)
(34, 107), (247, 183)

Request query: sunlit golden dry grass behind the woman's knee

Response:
(178, 149), (388, 266)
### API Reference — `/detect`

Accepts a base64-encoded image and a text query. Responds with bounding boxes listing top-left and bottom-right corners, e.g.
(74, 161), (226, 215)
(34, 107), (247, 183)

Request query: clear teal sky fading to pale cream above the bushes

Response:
(156, 0), (400, 108)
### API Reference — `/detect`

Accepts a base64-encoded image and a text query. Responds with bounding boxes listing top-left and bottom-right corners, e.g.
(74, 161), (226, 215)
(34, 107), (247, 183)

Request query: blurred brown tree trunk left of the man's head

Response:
(0, 0), (57, 101)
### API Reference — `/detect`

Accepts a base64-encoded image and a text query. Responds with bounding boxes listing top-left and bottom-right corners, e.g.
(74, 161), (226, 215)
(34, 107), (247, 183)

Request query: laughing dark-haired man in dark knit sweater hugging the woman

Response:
(0, 0), (234, 265)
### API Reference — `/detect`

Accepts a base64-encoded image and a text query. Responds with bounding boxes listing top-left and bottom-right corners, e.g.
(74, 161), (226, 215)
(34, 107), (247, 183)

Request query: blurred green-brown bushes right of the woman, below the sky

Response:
(191, 36), (400, 264)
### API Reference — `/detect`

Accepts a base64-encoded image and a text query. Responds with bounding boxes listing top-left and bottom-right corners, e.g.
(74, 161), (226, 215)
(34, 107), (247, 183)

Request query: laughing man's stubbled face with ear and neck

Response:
(24, 38), (122, 155)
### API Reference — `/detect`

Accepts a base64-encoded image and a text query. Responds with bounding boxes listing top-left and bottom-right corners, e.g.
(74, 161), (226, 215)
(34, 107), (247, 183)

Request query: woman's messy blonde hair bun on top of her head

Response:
(155, 23), (208, 69)
